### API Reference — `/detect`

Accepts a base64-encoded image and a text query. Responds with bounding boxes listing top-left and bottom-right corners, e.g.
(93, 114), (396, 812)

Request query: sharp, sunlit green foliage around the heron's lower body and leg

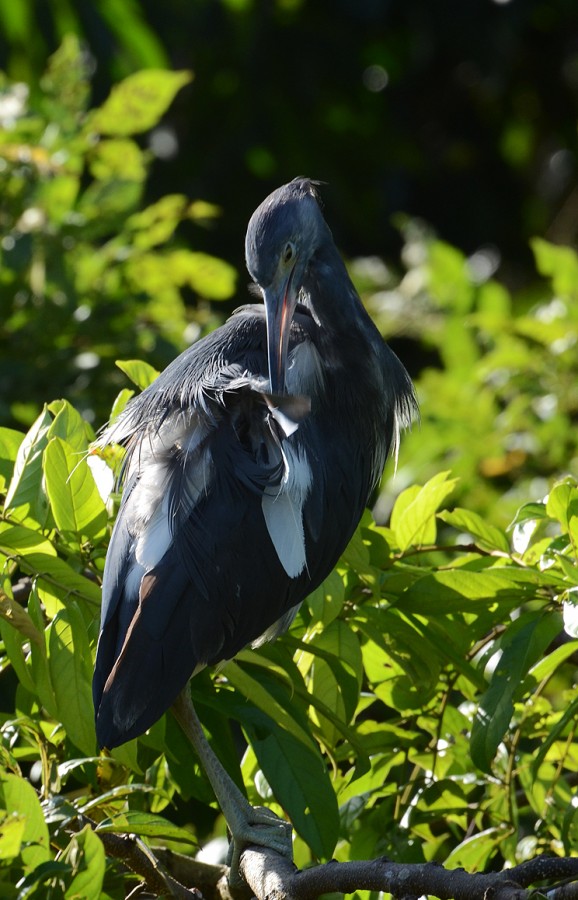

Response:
(0, 401), (578, 897)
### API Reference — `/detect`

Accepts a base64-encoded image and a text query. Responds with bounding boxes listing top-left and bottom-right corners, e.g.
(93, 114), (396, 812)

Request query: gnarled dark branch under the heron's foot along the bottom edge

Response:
(100, 834), (578, 900)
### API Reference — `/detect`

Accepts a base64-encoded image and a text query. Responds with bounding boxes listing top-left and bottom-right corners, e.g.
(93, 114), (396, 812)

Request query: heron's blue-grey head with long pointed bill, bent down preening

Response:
(245, 178), (329, 394)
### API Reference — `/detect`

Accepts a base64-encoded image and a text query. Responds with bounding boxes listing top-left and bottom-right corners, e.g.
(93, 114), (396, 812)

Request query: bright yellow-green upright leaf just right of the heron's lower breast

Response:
(391, 472), (457, 550)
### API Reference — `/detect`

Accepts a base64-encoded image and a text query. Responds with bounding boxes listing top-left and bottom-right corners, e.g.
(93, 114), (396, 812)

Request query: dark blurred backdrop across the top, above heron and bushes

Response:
(0, 0), (578, 270)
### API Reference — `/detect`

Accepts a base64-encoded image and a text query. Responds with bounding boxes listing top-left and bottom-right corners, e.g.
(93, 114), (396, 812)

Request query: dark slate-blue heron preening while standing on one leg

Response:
(93, 178), (416, 880)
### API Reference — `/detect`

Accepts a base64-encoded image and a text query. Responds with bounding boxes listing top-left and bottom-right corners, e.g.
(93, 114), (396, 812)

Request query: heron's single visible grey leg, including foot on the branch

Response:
(172, 685), (293, 881)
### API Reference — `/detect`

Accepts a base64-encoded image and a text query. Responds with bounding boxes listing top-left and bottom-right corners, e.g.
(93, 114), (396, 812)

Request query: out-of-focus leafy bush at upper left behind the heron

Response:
(0, 36), (236, 424)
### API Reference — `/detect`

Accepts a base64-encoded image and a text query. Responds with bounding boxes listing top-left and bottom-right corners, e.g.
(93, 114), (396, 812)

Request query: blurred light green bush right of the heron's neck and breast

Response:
(362, 222), (578, 530)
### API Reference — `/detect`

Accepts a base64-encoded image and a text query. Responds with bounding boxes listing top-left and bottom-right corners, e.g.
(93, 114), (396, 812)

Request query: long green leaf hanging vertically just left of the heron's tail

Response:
(48, 601), (96, 756)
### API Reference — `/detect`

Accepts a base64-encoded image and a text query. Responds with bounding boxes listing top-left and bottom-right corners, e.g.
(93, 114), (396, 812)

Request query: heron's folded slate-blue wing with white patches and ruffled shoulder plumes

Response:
(94, 313), (310, 747)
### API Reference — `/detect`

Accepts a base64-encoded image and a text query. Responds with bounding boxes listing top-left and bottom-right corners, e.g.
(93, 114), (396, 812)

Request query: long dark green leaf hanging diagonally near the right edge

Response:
(470, 614), (560, 772)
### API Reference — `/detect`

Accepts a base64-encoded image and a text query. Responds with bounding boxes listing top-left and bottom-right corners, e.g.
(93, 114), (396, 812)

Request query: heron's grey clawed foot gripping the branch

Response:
(228, 806), (293, 886)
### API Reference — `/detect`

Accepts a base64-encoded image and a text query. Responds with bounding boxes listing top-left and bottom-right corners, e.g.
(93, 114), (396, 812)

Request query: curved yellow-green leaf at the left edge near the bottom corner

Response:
(0, 769), (51, 871)
